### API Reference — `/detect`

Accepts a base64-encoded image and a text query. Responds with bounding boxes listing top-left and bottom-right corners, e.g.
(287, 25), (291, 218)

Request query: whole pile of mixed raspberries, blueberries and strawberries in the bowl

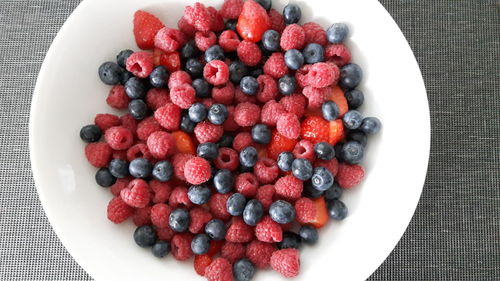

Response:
(80, 0), (381, 281)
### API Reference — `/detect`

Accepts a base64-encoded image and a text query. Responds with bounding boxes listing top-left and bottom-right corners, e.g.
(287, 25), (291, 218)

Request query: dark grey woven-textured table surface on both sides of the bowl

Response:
(0, 0), (500, 281)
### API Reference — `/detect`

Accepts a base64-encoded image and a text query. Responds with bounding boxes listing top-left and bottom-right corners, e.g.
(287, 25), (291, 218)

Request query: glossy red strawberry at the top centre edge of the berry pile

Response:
(236, 0), (271, 43)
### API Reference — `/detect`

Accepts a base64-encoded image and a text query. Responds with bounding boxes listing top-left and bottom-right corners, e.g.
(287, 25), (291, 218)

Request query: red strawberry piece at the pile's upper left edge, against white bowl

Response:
(134, 10), (165, 50)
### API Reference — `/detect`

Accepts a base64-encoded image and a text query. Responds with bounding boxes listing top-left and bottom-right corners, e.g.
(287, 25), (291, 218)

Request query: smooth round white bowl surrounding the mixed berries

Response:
(30, 0), (430, 281)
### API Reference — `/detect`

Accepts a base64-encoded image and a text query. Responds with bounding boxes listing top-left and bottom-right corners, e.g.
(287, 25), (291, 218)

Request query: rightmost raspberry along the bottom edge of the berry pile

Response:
(271, 248), (300, 278)
